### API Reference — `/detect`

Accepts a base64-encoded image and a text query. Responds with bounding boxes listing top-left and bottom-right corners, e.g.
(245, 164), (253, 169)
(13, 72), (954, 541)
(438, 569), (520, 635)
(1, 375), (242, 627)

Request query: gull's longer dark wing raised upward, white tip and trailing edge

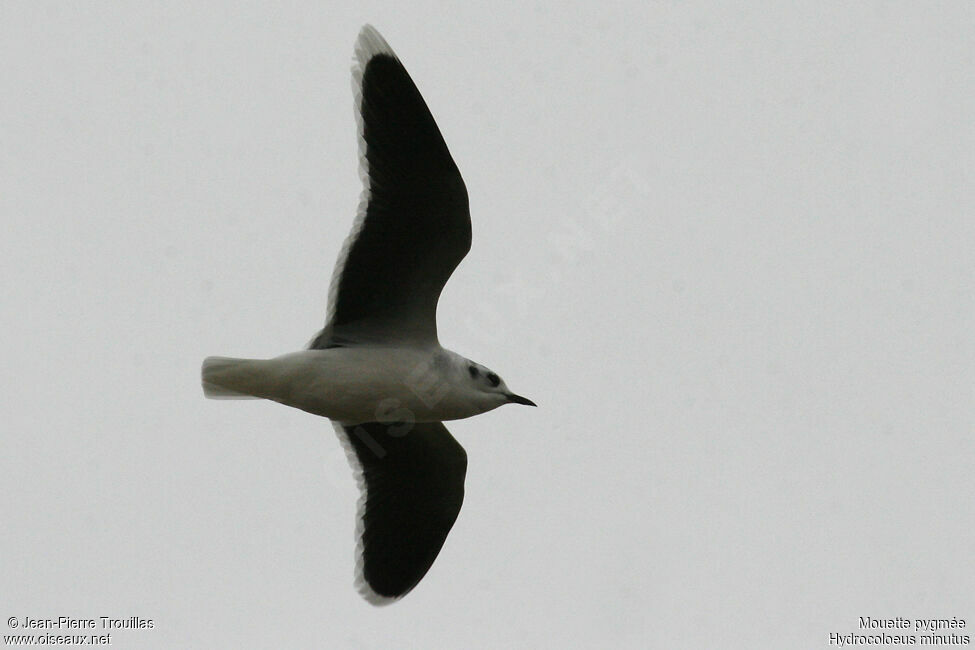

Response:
(311, 25), (471, 348)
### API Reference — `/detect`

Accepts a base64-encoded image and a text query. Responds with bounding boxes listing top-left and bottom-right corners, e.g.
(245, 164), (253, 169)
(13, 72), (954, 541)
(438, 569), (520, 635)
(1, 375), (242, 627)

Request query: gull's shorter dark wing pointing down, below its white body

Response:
(335, 422), (467, 605)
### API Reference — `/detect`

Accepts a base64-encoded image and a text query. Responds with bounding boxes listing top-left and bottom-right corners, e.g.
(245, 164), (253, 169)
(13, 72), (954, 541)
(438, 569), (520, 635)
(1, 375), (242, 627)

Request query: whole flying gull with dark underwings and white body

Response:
(202, 25), (535, 605)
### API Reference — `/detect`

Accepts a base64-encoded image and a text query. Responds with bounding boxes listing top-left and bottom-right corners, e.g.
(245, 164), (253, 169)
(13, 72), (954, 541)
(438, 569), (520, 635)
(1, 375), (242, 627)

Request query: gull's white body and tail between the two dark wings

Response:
(203, 346), (506, 424)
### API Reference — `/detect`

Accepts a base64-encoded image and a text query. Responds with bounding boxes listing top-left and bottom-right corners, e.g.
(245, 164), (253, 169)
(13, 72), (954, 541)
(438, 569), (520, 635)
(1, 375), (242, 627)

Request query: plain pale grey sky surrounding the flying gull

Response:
(0, 2), (975, 648)
